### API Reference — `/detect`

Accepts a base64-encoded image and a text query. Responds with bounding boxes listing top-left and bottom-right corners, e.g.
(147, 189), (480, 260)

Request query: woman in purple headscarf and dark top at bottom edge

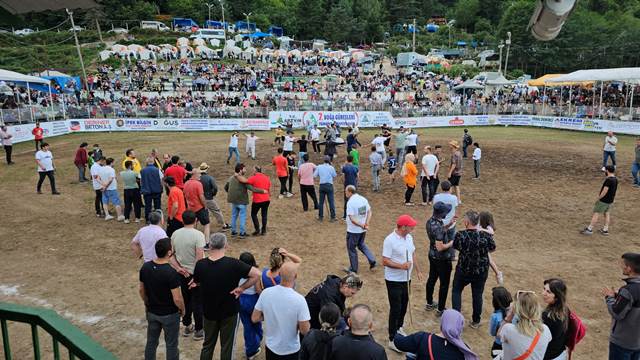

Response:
(393, 309), (478, 360)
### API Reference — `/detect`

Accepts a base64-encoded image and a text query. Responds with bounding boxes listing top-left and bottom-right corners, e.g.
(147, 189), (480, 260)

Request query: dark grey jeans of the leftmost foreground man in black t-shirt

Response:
(144, 311), (180, 360)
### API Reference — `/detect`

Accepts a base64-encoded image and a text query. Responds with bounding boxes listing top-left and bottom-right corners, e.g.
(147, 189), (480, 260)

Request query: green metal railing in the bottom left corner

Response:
(0, 302), (116, 360)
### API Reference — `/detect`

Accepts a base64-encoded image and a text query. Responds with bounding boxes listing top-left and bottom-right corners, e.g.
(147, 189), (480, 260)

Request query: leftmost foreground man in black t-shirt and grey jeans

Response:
(139, 238), (184, 359)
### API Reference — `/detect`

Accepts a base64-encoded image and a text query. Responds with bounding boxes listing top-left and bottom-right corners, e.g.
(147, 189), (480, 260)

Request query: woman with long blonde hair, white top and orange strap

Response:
(498, 291), (551, 360)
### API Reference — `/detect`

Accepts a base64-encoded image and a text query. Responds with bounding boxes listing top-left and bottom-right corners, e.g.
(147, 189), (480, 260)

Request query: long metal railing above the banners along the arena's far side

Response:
(0, 102), (640, 124)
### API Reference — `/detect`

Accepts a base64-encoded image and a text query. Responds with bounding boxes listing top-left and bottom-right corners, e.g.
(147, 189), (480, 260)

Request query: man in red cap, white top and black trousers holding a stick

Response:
(382, 215), (422, 352)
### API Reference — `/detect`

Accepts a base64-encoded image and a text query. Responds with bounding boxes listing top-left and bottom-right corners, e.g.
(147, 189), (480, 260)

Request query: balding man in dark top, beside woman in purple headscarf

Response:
(329, 304), (387, 360)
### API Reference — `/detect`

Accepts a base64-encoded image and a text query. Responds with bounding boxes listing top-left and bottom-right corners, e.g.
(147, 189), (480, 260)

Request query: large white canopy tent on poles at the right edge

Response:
(546, 67), (640, 117)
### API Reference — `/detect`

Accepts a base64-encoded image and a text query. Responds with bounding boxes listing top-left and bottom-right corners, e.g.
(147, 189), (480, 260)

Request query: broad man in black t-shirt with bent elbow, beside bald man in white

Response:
(193, 233), (260, 360)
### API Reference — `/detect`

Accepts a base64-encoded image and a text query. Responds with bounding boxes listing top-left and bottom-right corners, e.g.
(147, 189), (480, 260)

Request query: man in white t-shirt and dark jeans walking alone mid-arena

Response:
(344, 185), (376, 273)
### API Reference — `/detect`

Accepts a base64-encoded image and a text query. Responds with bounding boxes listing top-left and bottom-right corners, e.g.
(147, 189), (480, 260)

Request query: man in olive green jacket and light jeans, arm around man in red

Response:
(224, 164), (266, 239)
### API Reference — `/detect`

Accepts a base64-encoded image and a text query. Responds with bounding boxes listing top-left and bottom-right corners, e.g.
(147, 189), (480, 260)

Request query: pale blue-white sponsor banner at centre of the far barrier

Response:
(269, 111), (394, 129)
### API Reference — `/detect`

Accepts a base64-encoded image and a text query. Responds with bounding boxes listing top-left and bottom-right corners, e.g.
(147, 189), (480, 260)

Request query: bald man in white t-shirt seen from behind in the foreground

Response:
(251, 262), (311, 359)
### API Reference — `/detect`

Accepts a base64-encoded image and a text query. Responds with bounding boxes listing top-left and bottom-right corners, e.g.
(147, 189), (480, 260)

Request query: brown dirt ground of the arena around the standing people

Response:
(0, 127), (640, 359)
